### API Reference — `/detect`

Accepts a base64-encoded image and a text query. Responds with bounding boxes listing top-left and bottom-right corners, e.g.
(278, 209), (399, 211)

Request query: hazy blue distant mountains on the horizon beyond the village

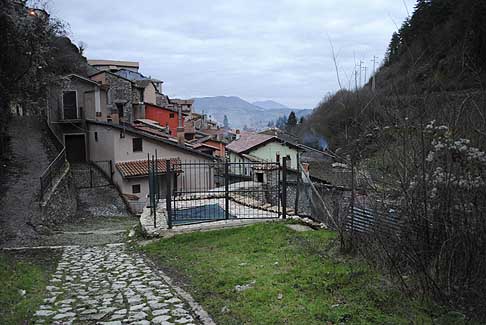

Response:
(193, 96), (312, 129)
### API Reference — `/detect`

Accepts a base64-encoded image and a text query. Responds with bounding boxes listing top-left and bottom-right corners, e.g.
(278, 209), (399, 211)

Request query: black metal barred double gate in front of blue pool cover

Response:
(165, 162), (287, 227)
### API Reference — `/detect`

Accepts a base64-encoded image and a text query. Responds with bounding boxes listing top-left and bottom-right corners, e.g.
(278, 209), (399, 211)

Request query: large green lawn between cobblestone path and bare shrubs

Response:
(141, 223), (440, 325)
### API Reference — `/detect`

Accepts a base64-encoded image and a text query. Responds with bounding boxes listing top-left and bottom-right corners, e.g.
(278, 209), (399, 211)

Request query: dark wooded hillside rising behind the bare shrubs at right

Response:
(301, 0), (486, 149)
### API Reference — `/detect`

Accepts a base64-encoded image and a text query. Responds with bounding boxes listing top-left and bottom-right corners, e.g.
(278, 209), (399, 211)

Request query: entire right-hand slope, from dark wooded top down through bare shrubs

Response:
(299, 0), (486, 318)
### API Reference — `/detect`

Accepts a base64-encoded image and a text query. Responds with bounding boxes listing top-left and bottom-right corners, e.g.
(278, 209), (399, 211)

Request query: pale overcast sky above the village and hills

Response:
(48, 0), (414, 108)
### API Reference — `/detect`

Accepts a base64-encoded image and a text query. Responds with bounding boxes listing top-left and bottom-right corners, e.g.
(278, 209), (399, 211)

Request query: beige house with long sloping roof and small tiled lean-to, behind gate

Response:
(87, 121), (214, 212)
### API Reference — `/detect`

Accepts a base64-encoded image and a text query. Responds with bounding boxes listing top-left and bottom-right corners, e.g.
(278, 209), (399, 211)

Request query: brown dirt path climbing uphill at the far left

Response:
(0, 117), (49, 246)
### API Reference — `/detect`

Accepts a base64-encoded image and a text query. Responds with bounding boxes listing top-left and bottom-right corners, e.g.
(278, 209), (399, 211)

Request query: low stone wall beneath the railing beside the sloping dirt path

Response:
(36, 165), (78, 233)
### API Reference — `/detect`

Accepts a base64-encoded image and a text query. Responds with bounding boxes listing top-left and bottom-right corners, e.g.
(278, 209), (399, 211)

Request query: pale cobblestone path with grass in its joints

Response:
(34, 244), (201, 325)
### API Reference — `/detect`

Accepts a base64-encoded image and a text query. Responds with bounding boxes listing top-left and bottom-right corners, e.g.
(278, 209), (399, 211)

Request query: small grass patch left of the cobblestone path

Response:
(0, 251), (59, 324)
